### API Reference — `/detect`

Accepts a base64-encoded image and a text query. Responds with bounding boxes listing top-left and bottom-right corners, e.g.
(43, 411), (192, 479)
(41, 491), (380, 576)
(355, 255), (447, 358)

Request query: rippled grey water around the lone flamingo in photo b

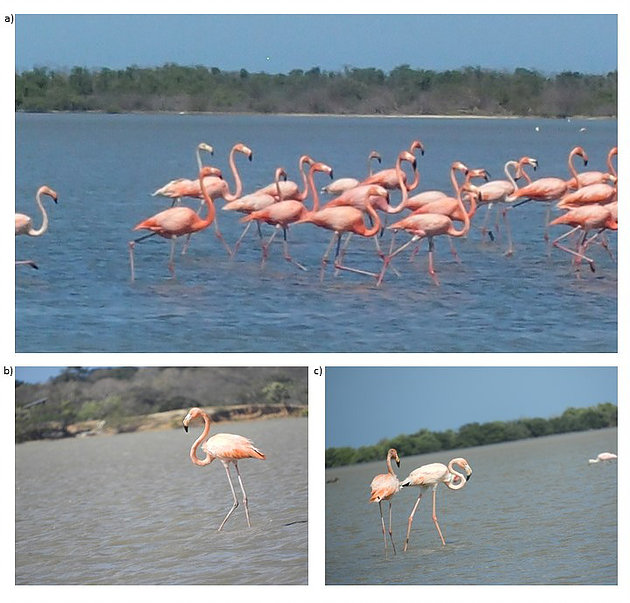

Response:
(15, 418), (308, 585)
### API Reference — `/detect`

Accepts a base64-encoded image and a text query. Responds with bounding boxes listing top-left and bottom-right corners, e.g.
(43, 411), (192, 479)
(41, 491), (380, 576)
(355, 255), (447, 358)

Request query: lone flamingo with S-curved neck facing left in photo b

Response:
(183, 407), (266, 532)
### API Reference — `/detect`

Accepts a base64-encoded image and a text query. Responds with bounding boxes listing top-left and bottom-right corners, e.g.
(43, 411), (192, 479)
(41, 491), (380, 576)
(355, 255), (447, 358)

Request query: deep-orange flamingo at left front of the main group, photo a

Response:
(129, 166), (215, 281)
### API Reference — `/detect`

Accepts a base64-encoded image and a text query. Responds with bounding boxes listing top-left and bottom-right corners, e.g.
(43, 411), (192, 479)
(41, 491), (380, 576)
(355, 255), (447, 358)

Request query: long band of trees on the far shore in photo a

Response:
(15, 64), (617, 117)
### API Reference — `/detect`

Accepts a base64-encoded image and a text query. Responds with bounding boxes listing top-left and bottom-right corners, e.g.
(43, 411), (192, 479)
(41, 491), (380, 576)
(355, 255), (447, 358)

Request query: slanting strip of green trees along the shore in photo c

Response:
(326, 402), (617, 467)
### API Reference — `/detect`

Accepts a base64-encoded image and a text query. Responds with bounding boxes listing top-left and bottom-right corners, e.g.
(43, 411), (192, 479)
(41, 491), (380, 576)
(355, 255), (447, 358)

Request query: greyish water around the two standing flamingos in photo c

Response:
(326, 428), (618, 585)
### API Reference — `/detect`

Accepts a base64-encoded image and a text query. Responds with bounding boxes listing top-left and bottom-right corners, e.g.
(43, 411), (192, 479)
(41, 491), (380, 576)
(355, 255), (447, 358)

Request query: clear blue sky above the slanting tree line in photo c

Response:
(326, 367), (617, 447)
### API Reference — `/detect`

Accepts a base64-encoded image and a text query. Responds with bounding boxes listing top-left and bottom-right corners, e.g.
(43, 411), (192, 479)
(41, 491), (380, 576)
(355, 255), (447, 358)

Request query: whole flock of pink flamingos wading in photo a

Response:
(15, 140), (617, 286)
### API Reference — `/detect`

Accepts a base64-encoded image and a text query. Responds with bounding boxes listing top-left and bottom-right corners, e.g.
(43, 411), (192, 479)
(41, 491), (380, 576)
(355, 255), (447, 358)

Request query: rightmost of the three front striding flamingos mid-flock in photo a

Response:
(377, 184), (477, 286)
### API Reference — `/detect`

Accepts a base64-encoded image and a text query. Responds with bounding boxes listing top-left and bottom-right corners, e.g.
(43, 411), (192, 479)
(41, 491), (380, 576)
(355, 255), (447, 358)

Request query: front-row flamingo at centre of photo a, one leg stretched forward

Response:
(295, 186), (381, 281)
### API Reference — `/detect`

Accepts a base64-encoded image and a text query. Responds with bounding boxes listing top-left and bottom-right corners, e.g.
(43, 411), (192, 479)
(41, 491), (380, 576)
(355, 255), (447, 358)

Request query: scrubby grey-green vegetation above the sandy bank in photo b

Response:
(15, 367), (307, 442)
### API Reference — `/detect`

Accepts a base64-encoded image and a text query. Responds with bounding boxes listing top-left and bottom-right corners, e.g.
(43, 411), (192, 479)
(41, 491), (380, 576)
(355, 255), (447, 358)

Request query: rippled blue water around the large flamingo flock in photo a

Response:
(15, 114), (617, 352)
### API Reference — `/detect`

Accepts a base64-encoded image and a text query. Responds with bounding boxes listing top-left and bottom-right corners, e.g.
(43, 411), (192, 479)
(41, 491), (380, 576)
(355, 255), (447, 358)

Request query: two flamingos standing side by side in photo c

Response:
(370, 448), (472, 555)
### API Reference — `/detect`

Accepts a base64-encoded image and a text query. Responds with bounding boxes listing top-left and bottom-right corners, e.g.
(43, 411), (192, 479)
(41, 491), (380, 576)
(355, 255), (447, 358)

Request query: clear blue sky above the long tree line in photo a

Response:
(15, 13), (617, 74)
